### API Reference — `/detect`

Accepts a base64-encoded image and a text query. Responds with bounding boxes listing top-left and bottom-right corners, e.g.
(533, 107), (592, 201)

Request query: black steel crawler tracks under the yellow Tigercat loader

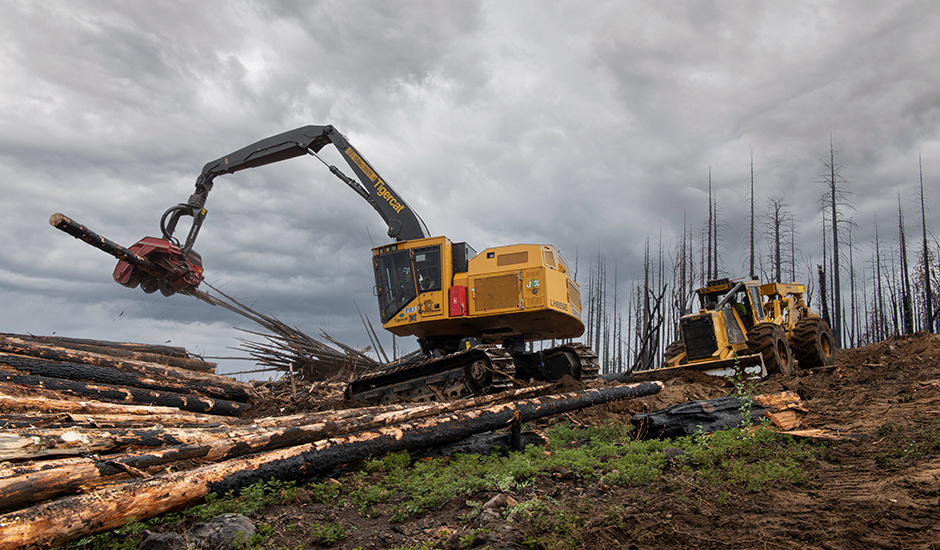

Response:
(346, 344), (599, 404)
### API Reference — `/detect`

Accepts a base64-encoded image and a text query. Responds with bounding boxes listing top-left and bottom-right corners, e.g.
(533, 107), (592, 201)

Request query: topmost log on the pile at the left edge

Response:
(0, 334), (216, 373)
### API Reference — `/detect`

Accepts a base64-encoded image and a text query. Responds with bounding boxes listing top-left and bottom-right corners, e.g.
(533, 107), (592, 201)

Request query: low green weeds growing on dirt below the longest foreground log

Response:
(68, 422), (824, 548)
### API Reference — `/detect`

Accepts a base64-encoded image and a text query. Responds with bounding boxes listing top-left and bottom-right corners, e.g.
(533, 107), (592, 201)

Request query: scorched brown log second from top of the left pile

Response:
(0, 338), (251, 401)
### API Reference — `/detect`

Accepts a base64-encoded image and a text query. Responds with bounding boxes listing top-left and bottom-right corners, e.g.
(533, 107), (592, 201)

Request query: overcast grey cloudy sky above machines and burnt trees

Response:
(0, 0), (940, 378)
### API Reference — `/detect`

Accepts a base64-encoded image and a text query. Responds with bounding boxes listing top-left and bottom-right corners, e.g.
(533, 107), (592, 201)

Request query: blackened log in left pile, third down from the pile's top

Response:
(0, 352), (249, 402)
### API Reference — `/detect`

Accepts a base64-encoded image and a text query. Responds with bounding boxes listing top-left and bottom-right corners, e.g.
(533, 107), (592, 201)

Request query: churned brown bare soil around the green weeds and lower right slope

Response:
(206, 334), (940, 550)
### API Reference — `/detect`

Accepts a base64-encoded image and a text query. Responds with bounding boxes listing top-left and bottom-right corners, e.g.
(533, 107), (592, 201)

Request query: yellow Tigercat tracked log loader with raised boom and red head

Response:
(114, 125), (598, 403)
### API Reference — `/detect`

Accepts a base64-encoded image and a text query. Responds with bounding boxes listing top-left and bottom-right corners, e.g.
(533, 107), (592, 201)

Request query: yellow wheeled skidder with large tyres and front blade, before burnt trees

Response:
(657, 279), (835, 376)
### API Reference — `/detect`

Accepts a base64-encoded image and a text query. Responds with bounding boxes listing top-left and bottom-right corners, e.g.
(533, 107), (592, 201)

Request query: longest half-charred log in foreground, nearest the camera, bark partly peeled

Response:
(0, 382), (662, 550)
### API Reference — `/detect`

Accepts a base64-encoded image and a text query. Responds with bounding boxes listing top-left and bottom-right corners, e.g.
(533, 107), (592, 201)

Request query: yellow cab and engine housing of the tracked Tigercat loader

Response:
(372, 237), (584, 348)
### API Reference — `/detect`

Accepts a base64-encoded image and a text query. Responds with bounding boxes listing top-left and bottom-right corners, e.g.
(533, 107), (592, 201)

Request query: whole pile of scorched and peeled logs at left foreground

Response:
(0, 335), (662, 550)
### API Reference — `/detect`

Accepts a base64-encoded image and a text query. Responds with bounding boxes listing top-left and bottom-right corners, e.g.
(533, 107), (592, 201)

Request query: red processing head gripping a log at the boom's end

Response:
(114, 237), (203, 296)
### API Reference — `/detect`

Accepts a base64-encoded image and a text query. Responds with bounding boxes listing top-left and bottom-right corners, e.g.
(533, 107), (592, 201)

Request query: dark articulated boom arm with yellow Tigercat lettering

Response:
(160, 125), (430, 253)
